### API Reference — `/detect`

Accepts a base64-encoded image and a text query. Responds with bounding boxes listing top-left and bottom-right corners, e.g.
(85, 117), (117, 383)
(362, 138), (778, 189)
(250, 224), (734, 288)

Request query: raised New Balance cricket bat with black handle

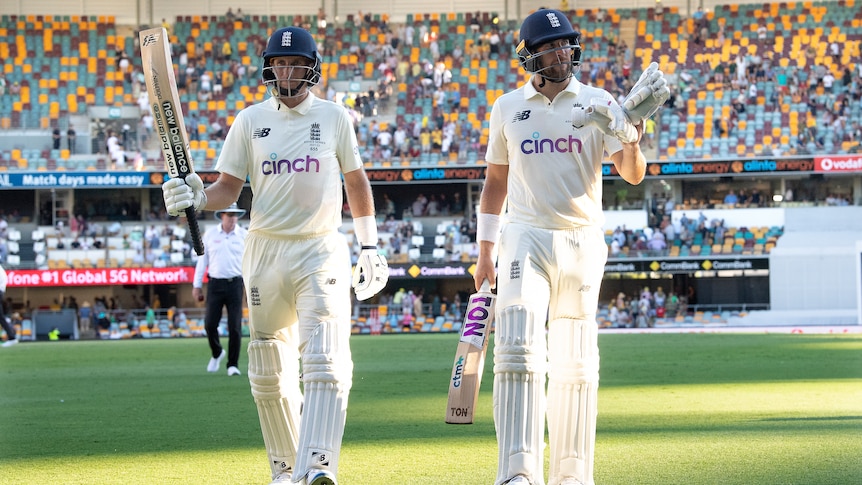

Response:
(140, 27), (204, 256)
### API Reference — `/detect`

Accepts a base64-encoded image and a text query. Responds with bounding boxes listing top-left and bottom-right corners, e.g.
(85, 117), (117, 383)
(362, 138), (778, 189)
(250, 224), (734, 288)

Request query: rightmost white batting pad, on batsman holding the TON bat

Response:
(548, 319), (599, 485)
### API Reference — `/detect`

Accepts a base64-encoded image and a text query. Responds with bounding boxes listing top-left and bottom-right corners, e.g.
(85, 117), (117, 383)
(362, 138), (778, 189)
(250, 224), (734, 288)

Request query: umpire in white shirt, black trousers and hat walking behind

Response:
(192, 203), (248, 376)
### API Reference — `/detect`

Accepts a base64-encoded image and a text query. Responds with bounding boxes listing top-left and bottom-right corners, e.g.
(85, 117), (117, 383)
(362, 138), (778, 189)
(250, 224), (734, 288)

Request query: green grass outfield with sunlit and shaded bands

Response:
(0, 334), (862, 485)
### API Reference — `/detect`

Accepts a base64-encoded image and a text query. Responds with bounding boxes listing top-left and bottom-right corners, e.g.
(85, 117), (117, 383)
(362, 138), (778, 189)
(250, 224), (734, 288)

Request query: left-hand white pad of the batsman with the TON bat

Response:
(494, 305), (546, 485)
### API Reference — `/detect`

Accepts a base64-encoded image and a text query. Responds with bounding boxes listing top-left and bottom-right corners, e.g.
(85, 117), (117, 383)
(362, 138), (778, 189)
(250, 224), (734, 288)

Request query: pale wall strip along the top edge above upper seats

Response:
(0, 0), (784, 25)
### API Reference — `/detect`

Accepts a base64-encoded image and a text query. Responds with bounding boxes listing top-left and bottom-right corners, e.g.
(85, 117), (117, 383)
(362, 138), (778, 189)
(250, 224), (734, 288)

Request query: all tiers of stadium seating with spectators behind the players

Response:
(0, 0), (862, 338)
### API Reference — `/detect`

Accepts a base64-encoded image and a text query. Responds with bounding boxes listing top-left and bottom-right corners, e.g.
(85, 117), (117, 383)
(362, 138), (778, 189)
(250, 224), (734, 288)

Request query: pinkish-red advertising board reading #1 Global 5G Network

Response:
(7, 266), (195, 288)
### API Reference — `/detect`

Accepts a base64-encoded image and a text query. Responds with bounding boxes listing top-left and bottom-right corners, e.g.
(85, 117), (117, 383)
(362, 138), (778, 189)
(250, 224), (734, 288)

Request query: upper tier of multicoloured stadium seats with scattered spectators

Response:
(0, 1), (862, 169)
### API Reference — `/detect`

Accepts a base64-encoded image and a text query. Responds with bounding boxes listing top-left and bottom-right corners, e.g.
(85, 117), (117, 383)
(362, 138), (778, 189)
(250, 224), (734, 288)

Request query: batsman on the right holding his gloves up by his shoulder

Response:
(474, 9), (669, 485)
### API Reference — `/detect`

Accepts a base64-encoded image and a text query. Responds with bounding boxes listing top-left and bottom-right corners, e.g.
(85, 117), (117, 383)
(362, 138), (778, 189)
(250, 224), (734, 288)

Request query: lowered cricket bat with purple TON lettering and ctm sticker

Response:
(446, 280), (497, 424)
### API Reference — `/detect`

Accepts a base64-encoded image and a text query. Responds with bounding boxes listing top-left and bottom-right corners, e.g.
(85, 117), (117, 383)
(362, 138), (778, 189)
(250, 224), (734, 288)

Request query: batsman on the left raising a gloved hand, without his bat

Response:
(162, 27), (389, 485)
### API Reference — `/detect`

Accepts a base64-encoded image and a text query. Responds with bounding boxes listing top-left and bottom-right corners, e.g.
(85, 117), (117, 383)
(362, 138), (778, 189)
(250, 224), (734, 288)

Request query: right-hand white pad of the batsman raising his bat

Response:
(294, 322), (353, 480)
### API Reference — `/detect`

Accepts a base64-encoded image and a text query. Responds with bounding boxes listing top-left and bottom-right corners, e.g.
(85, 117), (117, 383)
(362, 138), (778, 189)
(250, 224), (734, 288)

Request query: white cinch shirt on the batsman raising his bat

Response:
(216, 93), (362, 238)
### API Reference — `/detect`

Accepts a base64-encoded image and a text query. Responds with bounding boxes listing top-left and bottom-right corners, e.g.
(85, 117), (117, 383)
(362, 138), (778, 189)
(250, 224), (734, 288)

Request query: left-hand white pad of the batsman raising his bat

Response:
(248, 340), (302, 478)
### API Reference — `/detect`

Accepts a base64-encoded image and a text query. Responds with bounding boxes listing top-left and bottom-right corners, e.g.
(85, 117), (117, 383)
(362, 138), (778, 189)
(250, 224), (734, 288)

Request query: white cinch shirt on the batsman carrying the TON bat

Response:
(485, 78), (622, 229)
